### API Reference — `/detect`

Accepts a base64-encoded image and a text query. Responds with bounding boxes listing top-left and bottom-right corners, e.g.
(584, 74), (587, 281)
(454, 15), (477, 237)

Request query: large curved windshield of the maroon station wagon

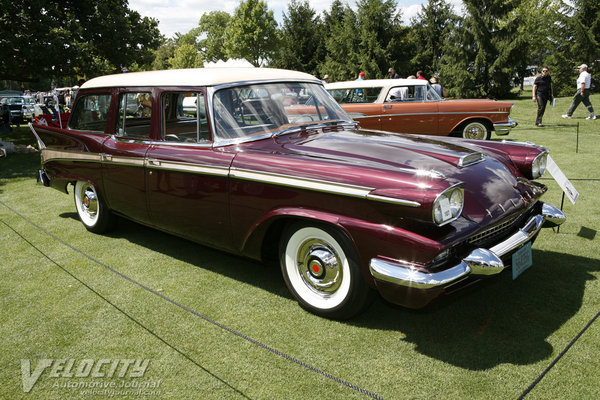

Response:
(213, 82), (352, 139)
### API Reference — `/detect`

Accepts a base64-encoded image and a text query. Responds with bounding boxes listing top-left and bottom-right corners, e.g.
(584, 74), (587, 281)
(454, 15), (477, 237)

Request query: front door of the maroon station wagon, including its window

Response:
(146, 91), (235, 250)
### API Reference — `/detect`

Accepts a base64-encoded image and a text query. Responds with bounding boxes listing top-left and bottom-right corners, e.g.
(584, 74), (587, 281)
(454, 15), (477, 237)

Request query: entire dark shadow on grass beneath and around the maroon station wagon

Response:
(61, 212), (600, 370)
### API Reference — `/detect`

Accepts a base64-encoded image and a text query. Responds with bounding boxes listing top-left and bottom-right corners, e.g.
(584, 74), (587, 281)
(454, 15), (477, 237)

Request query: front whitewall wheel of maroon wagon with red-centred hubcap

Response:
(279, 224), (372, 319)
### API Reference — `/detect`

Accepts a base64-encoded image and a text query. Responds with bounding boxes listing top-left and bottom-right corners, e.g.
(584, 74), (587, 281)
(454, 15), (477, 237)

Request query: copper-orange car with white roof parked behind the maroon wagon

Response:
(325, 79), (517, 139)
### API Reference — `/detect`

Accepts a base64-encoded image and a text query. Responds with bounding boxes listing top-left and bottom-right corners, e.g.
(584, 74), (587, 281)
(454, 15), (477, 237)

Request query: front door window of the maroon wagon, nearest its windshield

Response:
(161, 92), (210, 143)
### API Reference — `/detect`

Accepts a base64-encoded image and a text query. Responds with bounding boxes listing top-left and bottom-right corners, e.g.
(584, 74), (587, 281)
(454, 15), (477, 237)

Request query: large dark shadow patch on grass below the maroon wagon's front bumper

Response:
(351, 250), (600, 370)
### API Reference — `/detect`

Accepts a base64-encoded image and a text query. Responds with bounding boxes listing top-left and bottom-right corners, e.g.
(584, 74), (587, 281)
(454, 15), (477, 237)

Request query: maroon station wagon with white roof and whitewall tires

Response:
(31, 68), (565, 318)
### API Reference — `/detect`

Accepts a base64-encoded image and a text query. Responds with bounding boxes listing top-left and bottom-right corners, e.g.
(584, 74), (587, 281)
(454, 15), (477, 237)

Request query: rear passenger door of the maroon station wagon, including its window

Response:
(101, 90), (153, 227)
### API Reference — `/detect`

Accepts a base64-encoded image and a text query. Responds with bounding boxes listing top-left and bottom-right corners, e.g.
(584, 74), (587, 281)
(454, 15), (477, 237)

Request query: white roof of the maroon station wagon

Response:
(81, 68), (321, 89)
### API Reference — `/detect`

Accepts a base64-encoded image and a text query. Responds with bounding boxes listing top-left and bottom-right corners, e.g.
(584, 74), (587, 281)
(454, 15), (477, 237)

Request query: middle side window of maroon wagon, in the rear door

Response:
(117, 92), (152, 139)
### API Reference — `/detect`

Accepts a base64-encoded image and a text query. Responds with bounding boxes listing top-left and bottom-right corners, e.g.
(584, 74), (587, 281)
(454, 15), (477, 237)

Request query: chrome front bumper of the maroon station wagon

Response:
(369, 204), (566, 289)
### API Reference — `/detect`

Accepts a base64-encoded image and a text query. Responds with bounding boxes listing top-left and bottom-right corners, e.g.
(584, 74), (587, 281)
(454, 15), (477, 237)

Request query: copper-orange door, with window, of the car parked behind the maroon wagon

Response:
(381, 85), (439, 135)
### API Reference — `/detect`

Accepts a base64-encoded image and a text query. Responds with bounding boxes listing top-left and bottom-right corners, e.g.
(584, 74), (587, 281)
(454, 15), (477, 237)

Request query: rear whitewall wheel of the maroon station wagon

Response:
(74, 181), (116, 233)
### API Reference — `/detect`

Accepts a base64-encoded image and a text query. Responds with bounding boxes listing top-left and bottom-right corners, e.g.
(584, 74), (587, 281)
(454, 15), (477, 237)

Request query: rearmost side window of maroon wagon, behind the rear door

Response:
(69, 94), (111, 132)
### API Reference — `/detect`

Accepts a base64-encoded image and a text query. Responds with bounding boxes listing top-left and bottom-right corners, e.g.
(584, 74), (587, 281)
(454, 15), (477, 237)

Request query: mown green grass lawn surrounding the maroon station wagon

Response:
(0, 95), (600, 399)
